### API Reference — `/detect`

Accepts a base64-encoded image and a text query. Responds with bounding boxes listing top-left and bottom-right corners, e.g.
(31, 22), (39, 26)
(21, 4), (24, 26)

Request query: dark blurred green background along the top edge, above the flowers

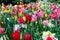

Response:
(0, 0), (60, 5)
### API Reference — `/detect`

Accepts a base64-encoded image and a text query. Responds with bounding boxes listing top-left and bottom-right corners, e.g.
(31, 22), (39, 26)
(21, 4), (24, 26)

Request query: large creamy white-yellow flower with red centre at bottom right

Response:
(42, 31), (57, 40)
